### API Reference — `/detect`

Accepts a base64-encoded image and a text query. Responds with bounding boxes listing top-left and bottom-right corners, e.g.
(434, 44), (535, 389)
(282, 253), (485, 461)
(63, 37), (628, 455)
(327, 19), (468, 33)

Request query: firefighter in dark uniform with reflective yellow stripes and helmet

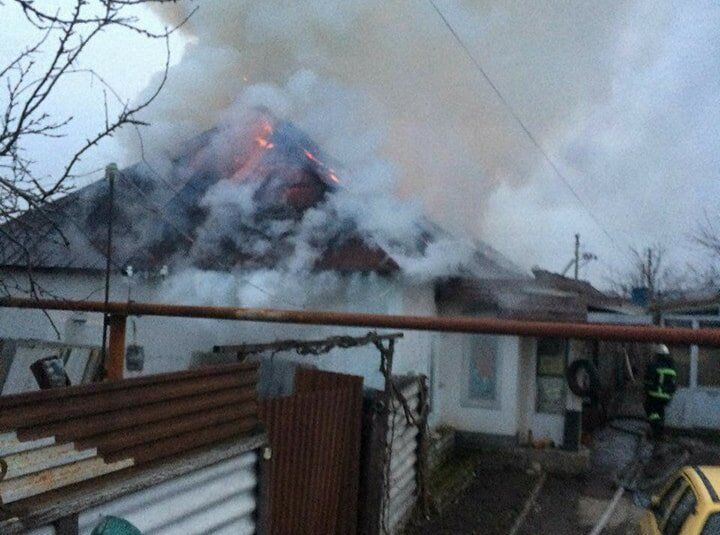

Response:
(644, 344), (677, 438)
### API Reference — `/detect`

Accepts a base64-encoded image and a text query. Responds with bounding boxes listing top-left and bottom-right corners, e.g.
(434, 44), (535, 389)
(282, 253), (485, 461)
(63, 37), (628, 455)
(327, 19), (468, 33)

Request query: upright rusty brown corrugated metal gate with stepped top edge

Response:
(260, 368), (363, 535)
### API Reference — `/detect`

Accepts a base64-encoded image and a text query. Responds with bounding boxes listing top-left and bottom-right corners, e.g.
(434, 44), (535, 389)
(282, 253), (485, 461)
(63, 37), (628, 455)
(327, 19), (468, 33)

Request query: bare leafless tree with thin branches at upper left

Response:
(0, 0), (194, 302)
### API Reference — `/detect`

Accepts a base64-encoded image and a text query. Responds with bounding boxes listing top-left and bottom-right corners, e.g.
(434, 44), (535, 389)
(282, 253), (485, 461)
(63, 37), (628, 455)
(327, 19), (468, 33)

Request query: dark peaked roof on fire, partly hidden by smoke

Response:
(0, 116), (526, 278)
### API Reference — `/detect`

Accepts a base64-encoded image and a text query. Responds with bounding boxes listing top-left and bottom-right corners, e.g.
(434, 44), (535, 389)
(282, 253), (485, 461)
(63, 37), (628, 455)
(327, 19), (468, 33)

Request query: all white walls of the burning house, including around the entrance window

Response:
(0, 268), (563, 444)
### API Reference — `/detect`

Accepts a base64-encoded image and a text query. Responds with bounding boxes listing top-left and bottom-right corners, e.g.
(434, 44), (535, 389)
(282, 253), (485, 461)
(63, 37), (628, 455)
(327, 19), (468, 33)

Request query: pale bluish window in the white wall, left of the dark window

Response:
(467, 336), (498, 408)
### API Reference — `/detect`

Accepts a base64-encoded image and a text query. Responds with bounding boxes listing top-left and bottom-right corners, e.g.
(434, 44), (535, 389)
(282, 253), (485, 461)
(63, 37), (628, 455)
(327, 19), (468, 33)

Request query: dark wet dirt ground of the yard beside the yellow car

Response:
(407, 424), (720, 535)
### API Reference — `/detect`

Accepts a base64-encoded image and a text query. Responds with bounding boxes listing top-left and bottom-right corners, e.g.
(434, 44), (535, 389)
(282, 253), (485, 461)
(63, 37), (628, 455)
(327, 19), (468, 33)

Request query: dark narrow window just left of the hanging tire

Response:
(535, 338), (566, 414)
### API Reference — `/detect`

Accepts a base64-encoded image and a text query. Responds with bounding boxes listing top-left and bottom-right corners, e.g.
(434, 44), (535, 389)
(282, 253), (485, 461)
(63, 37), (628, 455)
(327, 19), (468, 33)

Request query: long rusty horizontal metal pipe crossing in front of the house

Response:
(0, 298), (720, 347)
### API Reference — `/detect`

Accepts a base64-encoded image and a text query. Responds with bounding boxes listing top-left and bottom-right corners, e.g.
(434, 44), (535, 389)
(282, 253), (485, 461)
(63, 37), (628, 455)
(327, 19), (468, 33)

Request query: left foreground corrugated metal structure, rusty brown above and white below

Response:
(0, 363), (266, 534)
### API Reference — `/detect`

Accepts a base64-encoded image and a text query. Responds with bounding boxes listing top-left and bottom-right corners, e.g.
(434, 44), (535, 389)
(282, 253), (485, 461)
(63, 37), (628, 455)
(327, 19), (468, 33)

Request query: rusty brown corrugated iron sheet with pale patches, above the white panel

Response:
(0, 363), (258, 503)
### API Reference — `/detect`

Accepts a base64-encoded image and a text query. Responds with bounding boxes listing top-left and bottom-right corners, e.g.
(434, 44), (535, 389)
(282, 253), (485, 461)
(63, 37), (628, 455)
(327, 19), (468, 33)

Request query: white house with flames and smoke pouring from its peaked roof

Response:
(0, 109), (587, 446)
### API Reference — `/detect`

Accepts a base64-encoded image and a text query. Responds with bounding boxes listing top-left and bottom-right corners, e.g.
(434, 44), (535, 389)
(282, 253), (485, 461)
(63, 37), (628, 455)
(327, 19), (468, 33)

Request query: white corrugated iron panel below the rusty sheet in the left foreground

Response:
(79, 451), (258, 535)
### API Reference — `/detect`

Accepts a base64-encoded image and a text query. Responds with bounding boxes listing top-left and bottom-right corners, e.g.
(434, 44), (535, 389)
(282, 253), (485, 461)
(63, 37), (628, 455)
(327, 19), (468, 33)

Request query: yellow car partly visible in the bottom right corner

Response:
(640, 466), (720, 535)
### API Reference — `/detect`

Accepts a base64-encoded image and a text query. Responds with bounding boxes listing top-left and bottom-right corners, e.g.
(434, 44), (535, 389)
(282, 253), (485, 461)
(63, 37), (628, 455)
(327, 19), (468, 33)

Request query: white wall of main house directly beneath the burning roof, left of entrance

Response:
(0, 273), (435, 394)
